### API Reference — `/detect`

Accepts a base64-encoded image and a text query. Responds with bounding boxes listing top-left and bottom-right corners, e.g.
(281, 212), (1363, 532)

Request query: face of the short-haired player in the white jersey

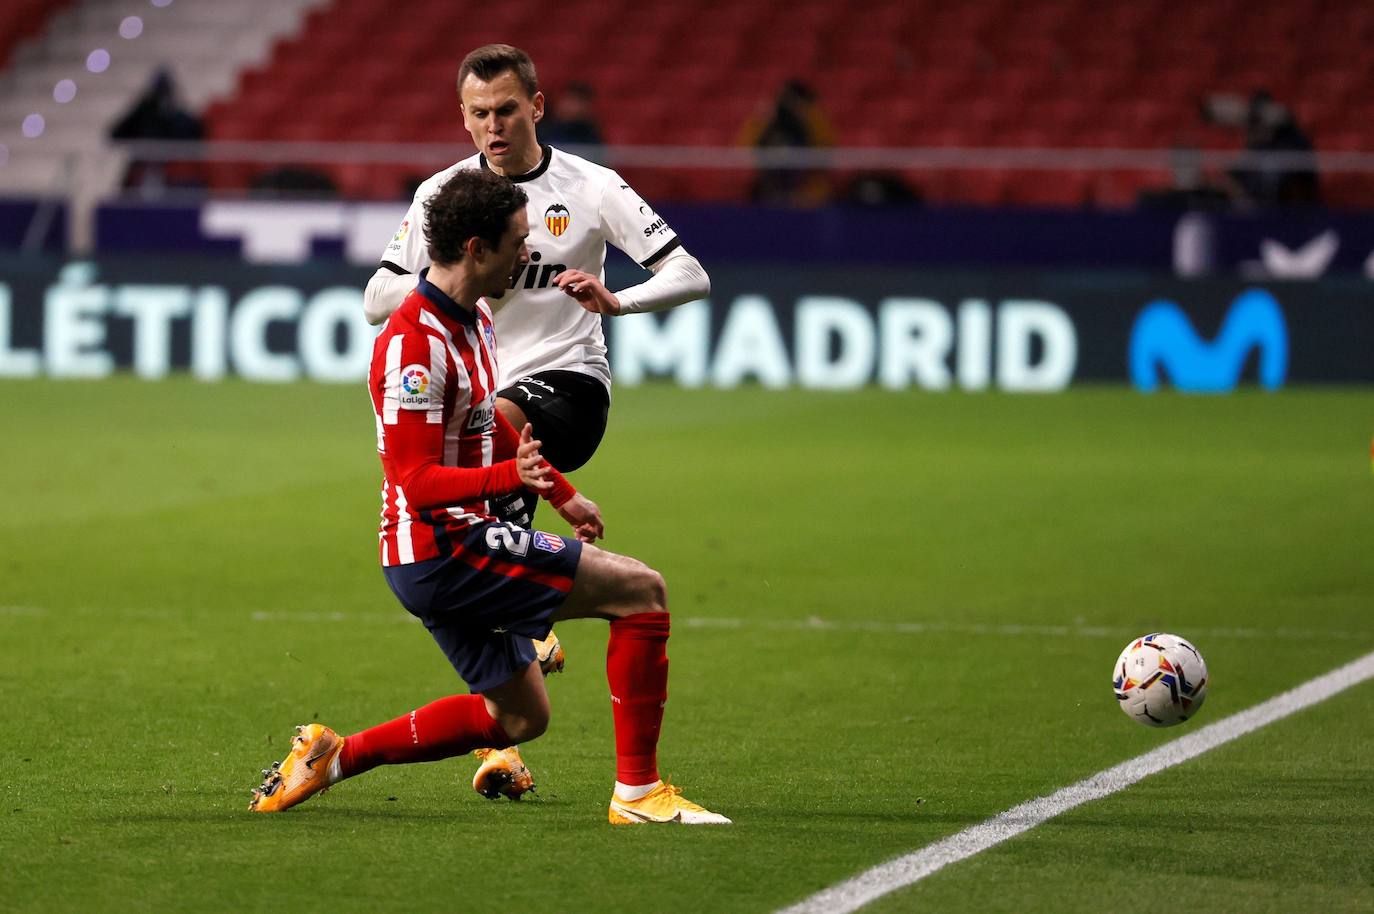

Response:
(459, 70), (544, 175)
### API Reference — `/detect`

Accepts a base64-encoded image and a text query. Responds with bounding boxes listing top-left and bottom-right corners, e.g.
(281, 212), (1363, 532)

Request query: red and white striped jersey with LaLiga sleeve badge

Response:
(368, 276), (508, 565)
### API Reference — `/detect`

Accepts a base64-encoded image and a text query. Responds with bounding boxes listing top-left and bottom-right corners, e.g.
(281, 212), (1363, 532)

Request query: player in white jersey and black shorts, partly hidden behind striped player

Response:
(364, 44), (710, 797)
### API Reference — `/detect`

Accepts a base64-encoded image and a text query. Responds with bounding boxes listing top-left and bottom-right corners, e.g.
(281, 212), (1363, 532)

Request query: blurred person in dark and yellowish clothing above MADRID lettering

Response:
(741, 80), (834, 206)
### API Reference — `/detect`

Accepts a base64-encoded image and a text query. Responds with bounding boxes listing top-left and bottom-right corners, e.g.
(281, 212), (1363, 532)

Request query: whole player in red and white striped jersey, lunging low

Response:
(250, 170), (730, 825)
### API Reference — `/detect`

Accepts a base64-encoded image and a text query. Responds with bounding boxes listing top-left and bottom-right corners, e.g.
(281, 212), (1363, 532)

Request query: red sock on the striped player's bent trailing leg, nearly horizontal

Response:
(339, 695), (511, 778)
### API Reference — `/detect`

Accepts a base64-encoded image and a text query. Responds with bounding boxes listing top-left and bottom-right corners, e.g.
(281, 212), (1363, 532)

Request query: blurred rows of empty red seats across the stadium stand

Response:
(196, 0), (1374, 206)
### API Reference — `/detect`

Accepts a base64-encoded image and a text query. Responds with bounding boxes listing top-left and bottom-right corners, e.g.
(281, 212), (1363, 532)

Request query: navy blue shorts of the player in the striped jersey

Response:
(382, 521), (583, 691)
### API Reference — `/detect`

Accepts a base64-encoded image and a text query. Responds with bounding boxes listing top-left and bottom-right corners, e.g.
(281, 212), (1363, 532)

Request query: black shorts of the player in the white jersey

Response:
(496, 371), (610, 473)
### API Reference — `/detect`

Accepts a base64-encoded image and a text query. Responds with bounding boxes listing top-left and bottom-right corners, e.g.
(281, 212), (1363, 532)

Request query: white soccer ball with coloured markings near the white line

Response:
(1112, 632), (1206, 727)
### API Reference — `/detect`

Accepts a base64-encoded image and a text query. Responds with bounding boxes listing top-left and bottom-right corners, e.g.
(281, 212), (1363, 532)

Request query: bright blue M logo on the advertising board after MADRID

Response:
(1129, 289), (1289, 393)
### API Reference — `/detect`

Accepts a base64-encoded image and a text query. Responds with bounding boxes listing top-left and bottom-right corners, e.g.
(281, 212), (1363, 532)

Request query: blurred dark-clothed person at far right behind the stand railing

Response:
(1202, 91), (1320, 206)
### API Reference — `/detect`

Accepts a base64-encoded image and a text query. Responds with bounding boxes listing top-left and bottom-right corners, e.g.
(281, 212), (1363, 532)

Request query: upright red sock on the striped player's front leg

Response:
(606, 613), (668, 786)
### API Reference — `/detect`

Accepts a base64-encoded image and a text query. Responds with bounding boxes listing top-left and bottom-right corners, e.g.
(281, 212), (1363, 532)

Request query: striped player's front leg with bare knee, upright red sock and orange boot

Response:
(552, 546), (730, 825)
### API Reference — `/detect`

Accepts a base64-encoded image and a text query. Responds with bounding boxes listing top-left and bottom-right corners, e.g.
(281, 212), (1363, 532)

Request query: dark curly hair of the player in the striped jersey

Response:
(425, 169), (529, 265)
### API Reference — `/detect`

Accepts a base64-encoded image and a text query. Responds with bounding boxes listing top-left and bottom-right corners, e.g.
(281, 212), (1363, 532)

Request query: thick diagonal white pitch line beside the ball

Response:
(778, 653), (1374, 914)
